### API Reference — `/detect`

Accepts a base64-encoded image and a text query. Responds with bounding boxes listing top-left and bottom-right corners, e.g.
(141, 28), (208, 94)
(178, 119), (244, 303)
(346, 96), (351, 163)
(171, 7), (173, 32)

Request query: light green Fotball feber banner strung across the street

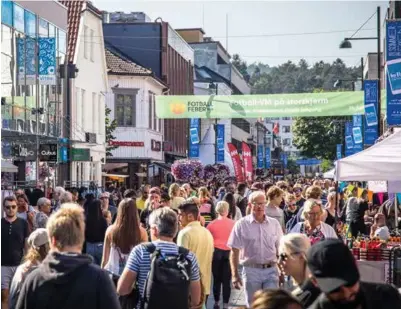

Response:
(156, 91), (378, 118)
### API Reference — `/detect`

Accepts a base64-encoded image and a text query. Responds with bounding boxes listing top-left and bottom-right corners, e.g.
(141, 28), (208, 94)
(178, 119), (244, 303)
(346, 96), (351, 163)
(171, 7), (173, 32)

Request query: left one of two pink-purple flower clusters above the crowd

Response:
(171, 159), (204, 185)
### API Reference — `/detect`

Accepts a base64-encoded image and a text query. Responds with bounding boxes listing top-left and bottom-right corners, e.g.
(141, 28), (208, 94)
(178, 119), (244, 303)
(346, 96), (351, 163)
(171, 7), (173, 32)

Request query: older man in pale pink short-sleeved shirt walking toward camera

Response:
(227, 191), (283, 307)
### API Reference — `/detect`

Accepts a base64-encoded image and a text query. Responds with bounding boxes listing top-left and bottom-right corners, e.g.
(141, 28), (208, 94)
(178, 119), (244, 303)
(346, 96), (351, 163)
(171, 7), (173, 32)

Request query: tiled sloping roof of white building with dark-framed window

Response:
(105, 46), (152, 75)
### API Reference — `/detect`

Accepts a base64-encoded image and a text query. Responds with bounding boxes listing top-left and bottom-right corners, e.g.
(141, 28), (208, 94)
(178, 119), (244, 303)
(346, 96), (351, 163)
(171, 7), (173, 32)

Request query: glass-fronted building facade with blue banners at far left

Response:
(1, 1), (67, 188)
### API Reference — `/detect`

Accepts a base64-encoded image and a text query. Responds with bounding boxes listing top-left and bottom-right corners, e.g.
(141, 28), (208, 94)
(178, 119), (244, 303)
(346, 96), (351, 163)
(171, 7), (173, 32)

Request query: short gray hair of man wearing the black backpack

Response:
(149, 207), (178, 238)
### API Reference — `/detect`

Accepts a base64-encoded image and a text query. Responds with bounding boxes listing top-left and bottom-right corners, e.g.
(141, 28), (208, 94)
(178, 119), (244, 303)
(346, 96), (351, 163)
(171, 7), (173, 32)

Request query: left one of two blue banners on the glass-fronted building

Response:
(17, 37), (36, 85)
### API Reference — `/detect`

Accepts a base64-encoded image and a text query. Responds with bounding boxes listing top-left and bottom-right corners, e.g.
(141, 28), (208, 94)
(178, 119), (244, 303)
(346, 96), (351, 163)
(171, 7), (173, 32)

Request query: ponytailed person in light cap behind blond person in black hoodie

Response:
(8, 228), (49, 309)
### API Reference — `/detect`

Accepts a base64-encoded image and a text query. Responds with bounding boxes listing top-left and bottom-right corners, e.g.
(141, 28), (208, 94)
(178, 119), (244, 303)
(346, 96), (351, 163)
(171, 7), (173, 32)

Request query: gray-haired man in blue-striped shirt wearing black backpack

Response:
(117, 207), (202, 309)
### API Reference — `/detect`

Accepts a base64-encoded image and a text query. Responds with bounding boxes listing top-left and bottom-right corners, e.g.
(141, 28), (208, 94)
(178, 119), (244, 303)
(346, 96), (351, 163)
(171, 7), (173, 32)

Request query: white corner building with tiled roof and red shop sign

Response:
(106, 46), (166, 188)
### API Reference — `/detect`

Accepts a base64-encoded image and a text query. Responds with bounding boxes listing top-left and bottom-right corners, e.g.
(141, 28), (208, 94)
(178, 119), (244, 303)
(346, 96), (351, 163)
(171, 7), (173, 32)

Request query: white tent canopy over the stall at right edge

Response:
(336, 130), (401, 181)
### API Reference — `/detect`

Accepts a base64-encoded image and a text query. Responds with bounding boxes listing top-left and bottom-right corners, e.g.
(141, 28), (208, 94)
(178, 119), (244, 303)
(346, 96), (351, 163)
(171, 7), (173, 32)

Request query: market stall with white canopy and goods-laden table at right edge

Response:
(335, 131), (401, 287)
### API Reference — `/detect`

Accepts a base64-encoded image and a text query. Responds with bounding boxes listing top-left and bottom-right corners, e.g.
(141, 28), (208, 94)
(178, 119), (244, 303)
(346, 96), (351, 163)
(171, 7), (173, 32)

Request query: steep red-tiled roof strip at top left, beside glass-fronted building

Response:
(60, 0), (86, 63)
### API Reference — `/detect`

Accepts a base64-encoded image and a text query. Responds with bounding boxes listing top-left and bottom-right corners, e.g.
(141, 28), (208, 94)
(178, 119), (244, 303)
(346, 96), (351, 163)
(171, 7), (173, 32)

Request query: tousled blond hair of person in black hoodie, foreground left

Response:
(46, 203), (85, 250)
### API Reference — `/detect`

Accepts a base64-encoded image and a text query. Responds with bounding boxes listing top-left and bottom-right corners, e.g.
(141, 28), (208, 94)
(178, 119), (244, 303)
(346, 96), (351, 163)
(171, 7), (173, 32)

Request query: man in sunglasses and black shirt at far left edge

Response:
(1, 196), (29, 309)
